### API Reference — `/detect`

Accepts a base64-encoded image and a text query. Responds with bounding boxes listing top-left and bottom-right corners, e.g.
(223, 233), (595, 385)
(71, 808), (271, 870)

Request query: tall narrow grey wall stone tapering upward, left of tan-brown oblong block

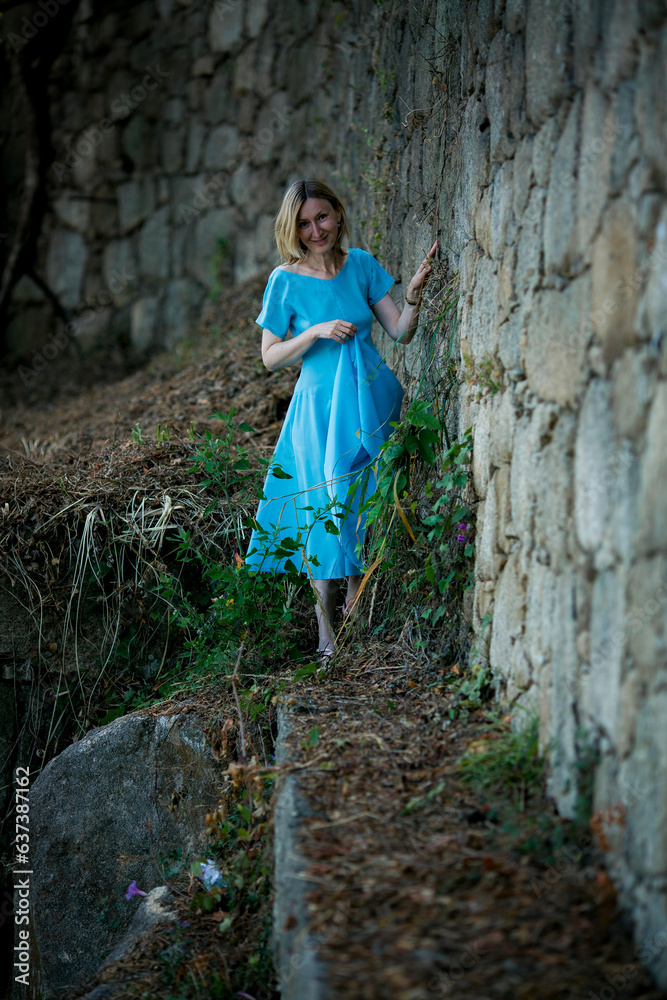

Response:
(544, 95), (581, 275)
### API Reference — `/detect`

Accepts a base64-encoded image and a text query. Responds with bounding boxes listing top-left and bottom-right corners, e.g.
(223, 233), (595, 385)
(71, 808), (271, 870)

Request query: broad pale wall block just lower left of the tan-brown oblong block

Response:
(521, 273), (590, 406)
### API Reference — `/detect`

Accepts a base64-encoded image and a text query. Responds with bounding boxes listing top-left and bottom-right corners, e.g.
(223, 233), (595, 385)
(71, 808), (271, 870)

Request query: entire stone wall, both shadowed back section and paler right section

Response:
(0, 0), (667, 984)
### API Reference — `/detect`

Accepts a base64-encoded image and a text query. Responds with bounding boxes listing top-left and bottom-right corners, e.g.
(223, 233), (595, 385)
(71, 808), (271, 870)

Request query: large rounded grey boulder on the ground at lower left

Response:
(30, 714), (218, 991)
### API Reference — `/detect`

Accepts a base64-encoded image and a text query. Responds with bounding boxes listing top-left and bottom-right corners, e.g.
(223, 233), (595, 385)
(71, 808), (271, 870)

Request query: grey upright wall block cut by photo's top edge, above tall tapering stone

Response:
(526, 0), (572, 126)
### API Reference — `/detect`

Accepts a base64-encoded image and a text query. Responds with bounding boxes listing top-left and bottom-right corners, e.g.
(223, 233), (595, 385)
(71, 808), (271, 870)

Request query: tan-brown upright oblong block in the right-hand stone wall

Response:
(591, 198), (639, 364)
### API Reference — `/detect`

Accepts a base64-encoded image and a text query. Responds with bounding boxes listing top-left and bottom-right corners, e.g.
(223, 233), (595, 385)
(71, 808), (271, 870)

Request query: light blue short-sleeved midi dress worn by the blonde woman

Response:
(245, 247), (403, 580)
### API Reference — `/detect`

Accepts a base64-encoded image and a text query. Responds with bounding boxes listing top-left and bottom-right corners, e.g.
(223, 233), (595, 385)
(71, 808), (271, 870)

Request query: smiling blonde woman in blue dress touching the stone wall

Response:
(246, 179), (438, 656)
